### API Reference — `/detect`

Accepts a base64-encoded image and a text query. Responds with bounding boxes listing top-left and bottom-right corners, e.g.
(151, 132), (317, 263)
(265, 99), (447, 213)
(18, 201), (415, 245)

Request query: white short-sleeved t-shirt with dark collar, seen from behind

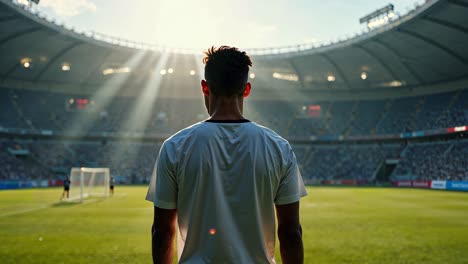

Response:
(146, 120), (307, 264)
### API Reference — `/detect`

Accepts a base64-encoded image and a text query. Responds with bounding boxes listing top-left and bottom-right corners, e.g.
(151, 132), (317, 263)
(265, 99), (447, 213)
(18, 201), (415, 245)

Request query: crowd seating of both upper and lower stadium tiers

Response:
(0, 88), (468, 183)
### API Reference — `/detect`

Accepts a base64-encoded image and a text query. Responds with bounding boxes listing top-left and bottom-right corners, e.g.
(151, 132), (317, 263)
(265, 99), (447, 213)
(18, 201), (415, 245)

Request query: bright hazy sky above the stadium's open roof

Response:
(35, 0), (416, 49)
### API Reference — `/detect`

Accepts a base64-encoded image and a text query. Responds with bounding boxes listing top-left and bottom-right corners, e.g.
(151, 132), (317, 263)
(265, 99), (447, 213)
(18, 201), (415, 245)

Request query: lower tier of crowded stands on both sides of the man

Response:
(0, 140), (468, 183)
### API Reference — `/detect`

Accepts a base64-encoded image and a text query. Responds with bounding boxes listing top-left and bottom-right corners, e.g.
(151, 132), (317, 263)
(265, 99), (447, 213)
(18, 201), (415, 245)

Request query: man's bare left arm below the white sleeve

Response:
(151, 206), (177, 264)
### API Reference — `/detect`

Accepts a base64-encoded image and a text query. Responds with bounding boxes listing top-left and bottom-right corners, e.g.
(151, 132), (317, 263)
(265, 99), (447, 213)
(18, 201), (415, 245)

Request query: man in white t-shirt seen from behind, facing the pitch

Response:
(146, 46), (307, 264)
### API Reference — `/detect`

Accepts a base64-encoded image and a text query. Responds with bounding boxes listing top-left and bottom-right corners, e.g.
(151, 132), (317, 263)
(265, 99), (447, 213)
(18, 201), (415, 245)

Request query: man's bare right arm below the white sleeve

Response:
(276, 202), (304, 264)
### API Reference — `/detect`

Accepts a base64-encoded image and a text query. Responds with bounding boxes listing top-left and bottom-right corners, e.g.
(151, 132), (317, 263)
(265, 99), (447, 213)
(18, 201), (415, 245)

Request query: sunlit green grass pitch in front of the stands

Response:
(0, 186), (468, 264)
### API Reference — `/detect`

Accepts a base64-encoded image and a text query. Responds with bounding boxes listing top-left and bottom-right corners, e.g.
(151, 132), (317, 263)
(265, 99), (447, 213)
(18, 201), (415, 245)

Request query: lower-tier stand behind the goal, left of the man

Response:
(0, 140), (160, 183)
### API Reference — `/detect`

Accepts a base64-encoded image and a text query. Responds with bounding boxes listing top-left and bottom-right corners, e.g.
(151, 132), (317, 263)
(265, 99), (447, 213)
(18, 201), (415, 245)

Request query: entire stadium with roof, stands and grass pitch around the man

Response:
(0, 0), (468, 263)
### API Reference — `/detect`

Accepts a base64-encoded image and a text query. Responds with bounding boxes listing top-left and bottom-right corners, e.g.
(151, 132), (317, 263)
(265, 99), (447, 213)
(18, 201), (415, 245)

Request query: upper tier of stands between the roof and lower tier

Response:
(0, 88), (468, 137)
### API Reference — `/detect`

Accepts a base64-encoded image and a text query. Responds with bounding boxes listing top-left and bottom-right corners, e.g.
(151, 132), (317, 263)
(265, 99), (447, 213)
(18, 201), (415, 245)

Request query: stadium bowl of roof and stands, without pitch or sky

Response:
(0, 0), (468, 189)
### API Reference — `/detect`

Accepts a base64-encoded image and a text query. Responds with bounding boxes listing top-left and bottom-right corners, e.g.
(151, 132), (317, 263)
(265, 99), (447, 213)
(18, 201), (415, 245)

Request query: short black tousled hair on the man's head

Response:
(203, 46), (252, 97)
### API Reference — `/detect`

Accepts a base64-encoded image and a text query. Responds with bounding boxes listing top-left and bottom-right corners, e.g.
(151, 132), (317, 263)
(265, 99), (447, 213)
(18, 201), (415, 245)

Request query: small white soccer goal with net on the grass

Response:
(68, 168), (110, 202)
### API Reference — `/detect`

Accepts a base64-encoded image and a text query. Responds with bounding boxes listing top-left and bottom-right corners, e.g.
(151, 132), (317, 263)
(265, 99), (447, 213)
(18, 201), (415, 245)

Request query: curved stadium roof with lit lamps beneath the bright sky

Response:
(0, 0), (468, 98)
